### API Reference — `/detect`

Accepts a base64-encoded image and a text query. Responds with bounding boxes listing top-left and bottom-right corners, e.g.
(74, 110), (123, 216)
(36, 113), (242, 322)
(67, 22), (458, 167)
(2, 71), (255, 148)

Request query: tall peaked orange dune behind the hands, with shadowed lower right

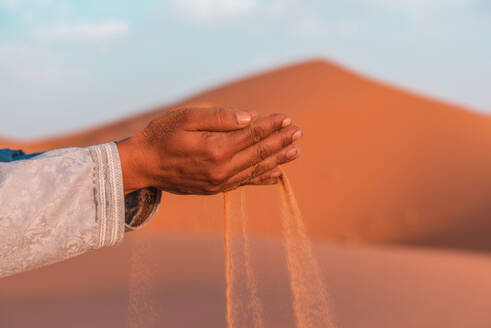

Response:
(2, 60), (491, 251)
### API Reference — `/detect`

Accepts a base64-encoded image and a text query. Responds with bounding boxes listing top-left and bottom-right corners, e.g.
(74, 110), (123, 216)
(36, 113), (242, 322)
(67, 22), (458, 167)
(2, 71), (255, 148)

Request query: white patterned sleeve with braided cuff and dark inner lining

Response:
(0, 143), (161, 277)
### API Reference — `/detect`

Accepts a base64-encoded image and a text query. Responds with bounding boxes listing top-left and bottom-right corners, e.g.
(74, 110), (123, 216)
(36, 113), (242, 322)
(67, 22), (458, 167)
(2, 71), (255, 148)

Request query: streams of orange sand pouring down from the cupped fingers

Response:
(224, 170), (335, 328)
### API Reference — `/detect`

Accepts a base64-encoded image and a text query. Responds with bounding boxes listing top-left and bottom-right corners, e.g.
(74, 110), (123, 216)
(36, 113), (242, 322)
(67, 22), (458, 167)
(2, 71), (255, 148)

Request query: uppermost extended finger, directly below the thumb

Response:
(227, 114), (292, 152)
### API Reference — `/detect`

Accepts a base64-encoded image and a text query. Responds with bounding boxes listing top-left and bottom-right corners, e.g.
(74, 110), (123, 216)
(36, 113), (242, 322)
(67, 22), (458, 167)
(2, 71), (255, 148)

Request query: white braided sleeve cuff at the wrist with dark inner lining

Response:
(89, 142), (162, 247)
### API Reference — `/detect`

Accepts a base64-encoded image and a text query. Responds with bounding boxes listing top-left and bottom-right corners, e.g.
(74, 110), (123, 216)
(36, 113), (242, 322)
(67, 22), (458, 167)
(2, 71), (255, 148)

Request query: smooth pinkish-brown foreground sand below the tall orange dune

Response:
(0, 233), (491, 328)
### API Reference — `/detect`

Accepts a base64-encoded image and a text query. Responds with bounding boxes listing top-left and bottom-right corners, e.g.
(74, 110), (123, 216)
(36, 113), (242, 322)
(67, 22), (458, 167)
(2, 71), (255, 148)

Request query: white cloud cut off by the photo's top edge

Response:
(173, 0), (257, 23)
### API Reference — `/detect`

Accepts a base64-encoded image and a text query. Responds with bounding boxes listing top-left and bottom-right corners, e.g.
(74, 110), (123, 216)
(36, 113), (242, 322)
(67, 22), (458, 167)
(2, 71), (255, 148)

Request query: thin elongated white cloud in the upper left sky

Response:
(32, 20), (129, 43)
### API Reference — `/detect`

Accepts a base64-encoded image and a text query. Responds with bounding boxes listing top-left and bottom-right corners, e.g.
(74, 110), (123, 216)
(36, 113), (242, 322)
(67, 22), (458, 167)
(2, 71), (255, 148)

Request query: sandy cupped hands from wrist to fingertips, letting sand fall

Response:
(118, 107), (303, 195)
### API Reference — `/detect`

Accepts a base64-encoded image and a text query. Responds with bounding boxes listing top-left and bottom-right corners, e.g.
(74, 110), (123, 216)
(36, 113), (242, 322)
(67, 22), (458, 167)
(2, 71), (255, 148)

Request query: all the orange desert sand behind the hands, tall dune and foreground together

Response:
(0, 60), (491, 328)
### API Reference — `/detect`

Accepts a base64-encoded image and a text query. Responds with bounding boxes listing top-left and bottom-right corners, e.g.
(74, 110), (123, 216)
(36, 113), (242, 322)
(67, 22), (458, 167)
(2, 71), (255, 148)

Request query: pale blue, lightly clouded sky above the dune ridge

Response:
(0, 0), (491, 138)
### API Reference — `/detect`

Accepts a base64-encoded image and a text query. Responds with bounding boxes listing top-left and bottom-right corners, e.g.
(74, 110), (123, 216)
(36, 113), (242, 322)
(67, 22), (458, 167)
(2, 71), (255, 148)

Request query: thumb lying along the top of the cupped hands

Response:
(182, 107), (257, 132)
